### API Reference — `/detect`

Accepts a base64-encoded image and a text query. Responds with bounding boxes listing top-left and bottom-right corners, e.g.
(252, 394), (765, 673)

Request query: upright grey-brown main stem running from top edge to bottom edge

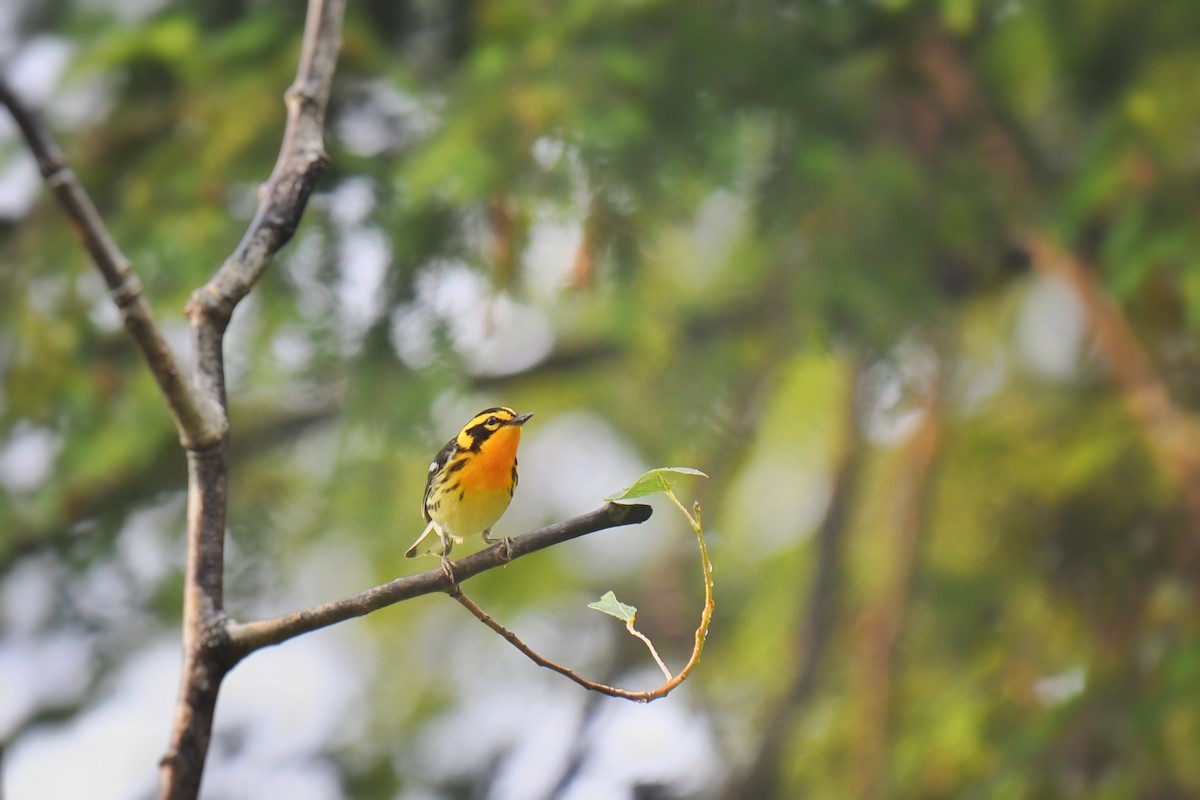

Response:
(160, 0), (346, 800)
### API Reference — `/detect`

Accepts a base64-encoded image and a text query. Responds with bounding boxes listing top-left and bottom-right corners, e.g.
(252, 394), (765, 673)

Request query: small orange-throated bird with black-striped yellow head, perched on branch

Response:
(404, 407), (533, 565)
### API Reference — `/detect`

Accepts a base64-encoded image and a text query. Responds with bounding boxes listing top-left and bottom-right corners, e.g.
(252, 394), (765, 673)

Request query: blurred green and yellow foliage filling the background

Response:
(0, 0), (1200, 798)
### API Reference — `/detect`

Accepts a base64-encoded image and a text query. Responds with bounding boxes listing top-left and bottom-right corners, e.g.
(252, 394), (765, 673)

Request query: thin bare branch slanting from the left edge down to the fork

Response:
(0, 76), (228, 449)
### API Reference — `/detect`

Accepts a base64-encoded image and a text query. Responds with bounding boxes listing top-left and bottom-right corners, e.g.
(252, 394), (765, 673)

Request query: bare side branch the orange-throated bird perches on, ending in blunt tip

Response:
(227, 503), (650, 658)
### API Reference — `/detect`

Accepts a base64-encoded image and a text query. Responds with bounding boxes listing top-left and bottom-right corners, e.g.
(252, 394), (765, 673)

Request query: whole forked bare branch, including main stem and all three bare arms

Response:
(7, 0), (667, 800)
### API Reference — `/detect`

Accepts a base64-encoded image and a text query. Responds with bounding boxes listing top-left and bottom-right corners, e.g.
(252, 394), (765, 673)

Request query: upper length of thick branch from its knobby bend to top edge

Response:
(188, 0), (346, 329)
